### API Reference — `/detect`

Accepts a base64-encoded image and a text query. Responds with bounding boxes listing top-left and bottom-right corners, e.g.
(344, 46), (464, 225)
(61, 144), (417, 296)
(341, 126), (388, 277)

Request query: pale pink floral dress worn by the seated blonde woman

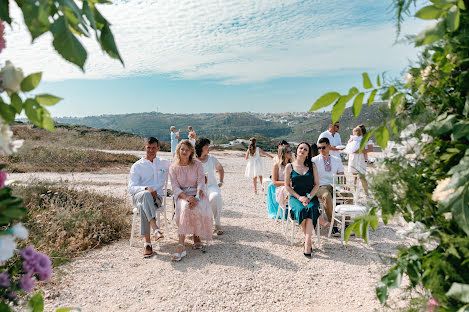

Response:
(169, 160), (213, 240)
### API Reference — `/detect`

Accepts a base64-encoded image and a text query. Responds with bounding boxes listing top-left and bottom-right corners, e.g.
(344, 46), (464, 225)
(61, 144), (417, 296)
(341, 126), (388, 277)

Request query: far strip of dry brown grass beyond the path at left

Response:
(5, 142), (138, 172)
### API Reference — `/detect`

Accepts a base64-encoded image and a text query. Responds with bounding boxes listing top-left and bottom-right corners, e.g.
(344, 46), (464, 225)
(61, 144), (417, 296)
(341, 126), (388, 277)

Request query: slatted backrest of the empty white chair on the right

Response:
(332, 174), (361, 207)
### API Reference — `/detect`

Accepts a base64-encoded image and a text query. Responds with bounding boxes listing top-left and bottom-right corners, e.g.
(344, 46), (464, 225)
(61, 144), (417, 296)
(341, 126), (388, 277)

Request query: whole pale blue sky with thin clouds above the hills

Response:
(1, 0), (424, 117)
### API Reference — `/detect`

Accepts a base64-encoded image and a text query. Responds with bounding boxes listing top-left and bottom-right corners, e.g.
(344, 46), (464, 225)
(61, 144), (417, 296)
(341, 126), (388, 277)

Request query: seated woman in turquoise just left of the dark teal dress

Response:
(267, 142), (292, 219)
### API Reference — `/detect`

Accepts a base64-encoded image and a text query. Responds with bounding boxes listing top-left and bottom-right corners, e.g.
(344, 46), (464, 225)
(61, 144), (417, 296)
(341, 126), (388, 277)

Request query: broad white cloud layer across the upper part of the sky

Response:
(1, 0), (420, 84)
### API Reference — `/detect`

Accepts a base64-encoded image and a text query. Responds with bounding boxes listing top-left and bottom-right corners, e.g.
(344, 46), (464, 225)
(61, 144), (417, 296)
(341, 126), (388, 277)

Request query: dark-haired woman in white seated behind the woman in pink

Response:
(195, 137), (225, 235)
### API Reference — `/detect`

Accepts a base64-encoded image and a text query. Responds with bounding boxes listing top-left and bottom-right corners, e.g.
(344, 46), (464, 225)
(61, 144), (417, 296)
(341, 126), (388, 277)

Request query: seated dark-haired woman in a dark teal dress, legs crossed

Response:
(285, 142), (319, 258)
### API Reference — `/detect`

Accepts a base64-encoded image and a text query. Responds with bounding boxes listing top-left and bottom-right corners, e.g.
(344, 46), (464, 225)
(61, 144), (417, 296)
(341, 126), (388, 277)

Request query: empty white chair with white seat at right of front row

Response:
(329, 174), (368, 245)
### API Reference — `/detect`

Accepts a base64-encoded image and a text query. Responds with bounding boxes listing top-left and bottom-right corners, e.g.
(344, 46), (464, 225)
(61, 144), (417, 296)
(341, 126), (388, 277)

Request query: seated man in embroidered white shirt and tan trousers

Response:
(312, 138), (344, 236)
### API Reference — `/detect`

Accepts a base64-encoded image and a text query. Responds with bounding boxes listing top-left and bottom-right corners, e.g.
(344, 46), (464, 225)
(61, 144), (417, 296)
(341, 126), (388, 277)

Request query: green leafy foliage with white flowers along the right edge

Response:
(308, 0), (469, 311)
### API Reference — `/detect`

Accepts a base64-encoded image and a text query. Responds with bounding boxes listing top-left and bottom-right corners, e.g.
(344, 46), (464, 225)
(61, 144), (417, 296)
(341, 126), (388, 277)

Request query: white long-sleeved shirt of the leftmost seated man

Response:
(127, 157), (171, 195)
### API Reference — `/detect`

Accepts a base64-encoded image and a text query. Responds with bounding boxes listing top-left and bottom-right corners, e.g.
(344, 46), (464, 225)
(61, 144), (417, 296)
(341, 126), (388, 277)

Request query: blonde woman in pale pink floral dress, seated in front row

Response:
(169, 140), (213, 261)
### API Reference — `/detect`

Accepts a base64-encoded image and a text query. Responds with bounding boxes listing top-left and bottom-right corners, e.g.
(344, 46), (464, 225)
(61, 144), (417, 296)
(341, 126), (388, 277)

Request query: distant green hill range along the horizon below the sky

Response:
(54, 103), (382, 143)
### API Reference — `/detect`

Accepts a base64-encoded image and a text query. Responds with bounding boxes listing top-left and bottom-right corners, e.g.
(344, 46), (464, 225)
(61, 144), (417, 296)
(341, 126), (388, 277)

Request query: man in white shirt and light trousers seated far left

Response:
(128, 137), (171, 257)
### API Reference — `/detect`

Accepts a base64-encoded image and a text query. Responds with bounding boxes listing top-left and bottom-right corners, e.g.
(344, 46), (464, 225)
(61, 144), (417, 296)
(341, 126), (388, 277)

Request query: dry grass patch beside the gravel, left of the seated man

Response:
(15, 181), (130, 265)
